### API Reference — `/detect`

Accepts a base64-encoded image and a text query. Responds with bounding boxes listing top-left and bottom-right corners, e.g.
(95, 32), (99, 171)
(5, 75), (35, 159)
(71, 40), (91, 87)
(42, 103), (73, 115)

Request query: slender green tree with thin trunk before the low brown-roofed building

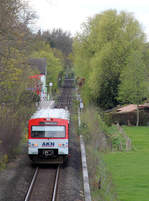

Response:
(118, 51), (149, 126)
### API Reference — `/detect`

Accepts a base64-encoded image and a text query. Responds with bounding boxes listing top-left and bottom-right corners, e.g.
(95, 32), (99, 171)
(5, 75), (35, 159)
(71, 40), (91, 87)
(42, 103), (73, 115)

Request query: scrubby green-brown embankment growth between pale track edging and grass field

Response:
(80, 107), (131, 201)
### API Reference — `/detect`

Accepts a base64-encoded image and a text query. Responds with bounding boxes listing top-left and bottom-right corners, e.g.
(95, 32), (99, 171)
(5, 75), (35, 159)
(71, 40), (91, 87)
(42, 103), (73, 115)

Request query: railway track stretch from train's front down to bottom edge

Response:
(24, 166), (60, 201)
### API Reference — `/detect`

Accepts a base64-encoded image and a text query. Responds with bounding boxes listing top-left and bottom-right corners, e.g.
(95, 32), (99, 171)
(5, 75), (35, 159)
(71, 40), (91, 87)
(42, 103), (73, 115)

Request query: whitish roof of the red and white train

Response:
(31, 108), (70, 121)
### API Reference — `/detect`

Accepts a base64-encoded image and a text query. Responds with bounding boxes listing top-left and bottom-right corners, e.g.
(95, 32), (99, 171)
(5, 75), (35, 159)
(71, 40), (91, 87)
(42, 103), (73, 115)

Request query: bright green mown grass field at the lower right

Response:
(103, 127), (149, 201)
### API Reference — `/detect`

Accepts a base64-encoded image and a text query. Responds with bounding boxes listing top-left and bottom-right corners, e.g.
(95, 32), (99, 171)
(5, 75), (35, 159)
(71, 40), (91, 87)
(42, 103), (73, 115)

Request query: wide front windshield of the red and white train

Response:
(31, 126), (66, 138)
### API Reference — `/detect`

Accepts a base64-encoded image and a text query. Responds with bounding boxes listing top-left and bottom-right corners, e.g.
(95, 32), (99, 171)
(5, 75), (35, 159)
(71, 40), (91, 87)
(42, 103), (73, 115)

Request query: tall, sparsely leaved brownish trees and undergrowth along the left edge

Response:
(0, 0), (39, 160)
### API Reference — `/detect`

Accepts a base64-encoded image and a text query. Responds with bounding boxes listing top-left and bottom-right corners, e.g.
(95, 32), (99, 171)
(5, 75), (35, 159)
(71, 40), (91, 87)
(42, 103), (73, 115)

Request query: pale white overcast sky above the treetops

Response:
(28, 0), (149, 39)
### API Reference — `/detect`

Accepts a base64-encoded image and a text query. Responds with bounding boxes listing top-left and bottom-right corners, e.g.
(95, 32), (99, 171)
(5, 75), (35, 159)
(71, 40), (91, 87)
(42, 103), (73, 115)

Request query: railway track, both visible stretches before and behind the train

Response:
(24, 79), (74, 201)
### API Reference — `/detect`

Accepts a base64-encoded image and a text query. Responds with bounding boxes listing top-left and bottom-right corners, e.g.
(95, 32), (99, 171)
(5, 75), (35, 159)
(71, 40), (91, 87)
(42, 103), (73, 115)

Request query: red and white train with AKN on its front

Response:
(28, 108), (70, 163)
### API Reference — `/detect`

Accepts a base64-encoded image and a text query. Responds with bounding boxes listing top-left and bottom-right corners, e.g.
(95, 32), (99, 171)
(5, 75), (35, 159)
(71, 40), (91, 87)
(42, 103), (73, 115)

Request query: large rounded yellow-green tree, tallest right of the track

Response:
(73, 10), (144, 109)
